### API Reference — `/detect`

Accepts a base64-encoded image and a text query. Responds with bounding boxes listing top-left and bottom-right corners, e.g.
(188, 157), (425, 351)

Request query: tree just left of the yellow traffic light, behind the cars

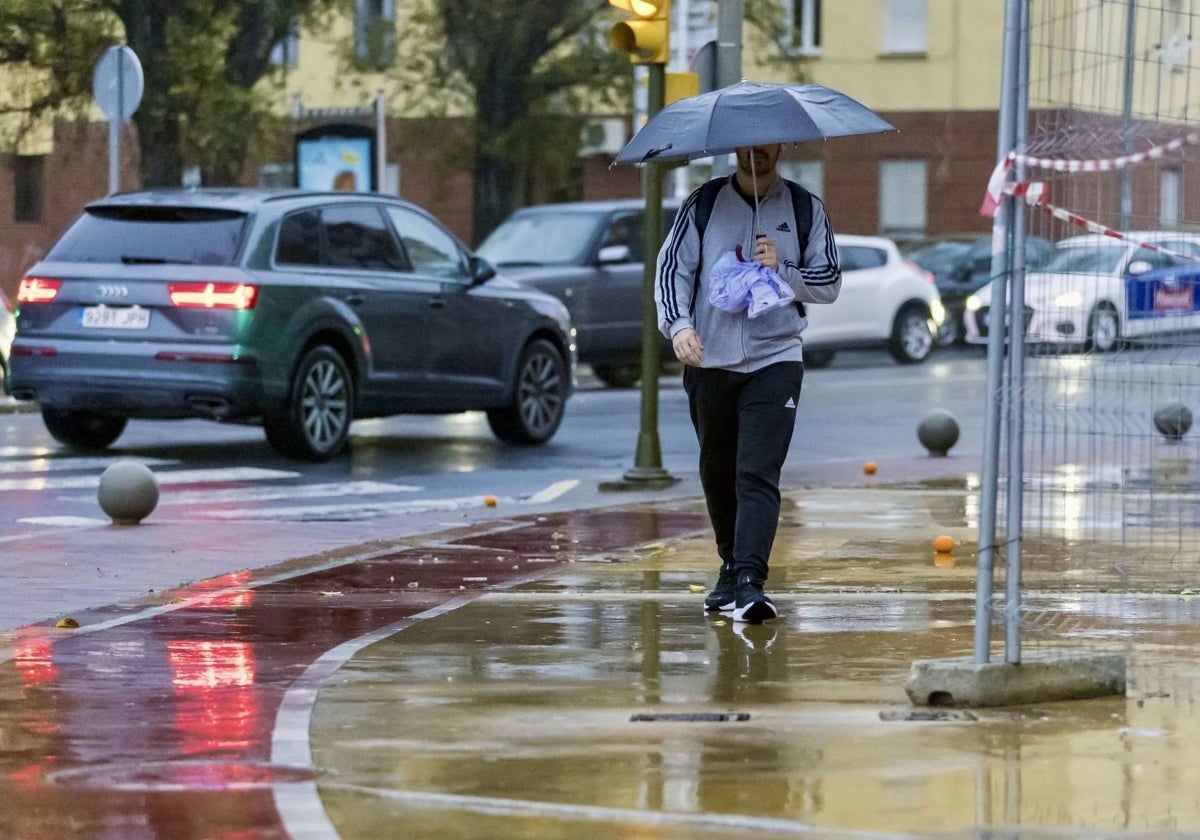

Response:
(392, 0), (802, 240)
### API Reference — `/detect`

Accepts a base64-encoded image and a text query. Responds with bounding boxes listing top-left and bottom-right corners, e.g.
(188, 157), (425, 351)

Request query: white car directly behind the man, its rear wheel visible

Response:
(804, 233), (946, 367)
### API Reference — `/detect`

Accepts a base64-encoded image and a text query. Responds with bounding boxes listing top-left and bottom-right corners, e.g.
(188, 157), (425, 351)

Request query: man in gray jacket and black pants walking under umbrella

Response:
(654, 144), (841, 623)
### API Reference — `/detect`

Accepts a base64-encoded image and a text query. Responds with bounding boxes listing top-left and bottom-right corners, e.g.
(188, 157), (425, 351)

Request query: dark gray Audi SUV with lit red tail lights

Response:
(6, 190), (575, 461)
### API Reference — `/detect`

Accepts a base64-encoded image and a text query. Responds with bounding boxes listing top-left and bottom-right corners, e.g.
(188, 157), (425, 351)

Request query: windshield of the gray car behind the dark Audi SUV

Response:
(476, 212), (604, 268)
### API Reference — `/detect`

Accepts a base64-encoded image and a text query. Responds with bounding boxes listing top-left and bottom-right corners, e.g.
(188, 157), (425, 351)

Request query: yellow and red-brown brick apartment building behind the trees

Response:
(0, 0), (1003, 300)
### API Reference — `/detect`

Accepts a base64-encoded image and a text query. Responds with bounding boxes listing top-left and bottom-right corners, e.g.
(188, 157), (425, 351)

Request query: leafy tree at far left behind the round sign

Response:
(0, 0), (342, 186)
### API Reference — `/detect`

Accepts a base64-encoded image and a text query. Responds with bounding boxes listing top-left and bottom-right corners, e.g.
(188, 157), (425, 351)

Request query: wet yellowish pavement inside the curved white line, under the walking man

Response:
(313, 493), (1200, 840)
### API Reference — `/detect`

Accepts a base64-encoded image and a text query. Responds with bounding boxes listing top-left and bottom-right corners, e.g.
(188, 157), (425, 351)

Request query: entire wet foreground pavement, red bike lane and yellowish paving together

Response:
(7, 462), (1200, 840)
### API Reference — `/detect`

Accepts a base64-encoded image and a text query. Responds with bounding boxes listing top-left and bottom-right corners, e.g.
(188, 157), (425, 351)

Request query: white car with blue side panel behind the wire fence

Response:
(964, 232), (1200, 352)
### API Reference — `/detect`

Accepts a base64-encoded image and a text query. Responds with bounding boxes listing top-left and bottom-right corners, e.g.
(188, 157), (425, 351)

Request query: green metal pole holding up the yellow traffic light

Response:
(624, 64), (677, 487)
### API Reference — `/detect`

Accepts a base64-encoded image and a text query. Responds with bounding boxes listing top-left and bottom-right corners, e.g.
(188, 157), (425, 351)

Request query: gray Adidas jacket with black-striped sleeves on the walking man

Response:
(654, 178), (841, 372)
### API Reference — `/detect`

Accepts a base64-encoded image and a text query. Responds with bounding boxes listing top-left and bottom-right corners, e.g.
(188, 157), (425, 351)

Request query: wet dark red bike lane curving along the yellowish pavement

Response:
(0, 505), (706, 840)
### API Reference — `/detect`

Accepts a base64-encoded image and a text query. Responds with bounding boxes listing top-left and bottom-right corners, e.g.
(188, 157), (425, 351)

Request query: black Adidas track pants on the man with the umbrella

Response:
(683, 361), (804, 581)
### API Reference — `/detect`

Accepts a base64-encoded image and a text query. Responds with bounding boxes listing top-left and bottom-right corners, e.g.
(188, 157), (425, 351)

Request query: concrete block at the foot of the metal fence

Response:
(905, 650), (1126, 708)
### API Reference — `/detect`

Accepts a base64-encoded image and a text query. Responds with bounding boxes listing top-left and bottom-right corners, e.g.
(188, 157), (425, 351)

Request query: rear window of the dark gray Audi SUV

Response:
(46, 205), (246, 265)
